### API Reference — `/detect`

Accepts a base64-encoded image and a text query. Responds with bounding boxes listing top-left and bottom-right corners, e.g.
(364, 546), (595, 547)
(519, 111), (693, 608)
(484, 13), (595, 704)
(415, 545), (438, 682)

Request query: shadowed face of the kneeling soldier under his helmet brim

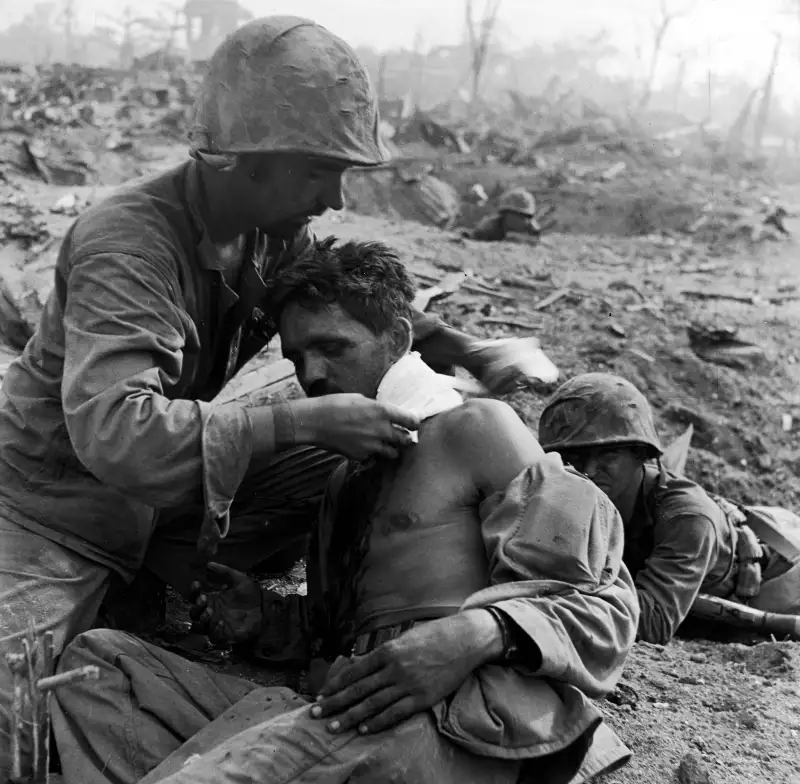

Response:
(237, 153), (348, 237)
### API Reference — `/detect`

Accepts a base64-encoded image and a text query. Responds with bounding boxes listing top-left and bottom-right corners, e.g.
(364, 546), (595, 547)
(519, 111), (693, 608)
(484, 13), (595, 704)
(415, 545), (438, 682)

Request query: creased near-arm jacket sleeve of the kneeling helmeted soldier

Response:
(61, 254), (252, 508)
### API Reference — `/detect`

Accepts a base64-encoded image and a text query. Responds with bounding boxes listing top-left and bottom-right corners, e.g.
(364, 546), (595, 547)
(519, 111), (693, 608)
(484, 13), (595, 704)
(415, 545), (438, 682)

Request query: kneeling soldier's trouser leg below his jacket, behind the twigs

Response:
(0, 517), (109, 782)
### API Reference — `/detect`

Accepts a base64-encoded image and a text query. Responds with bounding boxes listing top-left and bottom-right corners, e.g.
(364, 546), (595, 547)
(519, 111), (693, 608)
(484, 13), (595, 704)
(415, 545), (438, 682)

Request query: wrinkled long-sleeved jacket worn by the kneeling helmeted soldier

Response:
(0, 161), (476, 578)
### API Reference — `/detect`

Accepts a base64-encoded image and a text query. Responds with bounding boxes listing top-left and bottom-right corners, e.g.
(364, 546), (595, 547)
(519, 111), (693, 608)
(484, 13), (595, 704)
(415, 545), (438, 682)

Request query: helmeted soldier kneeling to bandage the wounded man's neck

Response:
(0, 17), (544, 779)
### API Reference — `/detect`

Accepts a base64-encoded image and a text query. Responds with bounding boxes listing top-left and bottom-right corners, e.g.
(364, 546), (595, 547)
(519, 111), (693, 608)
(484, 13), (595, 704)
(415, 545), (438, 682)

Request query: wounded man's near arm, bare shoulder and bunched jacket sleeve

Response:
(446, 401), (638, 695)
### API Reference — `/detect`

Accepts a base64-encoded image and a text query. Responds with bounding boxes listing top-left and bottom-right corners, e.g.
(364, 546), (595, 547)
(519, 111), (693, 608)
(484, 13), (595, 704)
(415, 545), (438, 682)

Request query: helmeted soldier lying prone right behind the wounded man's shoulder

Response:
(539, 373), (800, 643)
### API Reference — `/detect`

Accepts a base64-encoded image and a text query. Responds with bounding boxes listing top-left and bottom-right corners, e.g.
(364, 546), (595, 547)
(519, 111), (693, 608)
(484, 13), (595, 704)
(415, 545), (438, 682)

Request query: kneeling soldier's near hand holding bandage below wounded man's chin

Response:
(292, 394), (419, 460)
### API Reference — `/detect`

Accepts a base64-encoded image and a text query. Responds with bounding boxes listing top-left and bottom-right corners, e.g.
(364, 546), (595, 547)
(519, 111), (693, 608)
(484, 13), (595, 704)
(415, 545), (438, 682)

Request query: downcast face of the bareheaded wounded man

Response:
(280, 302), (397, 398)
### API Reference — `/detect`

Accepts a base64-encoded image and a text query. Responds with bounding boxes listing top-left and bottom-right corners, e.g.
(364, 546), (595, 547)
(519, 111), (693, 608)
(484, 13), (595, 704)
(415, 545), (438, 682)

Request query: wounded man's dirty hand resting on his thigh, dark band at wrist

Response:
(311, 610), (503, 734)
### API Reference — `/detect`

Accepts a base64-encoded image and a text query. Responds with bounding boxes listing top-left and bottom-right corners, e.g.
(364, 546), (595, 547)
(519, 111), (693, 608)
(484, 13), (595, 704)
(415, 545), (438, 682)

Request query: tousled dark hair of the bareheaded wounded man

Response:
(267, 237), (416, 334)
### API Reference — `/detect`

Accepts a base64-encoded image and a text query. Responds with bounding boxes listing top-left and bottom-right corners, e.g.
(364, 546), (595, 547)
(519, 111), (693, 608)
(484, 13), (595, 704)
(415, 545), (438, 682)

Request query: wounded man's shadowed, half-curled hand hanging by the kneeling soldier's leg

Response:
(189, 563), (262, 643)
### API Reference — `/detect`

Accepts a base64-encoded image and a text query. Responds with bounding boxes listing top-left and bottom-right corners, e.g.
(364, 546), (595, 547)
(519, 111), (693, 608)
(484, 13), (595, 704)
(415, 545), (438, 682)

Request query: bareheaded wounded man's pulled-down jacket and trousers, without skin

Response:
(54, 456), (638, 784)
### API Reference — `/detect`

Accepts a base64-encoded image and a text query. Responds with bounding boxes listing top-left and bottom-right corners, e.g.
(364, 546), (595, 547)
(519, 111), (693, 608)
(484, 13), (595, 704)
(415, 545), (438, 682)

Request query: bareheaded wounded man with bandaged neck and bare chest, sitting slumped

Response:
(53, 240), (638, 784)
